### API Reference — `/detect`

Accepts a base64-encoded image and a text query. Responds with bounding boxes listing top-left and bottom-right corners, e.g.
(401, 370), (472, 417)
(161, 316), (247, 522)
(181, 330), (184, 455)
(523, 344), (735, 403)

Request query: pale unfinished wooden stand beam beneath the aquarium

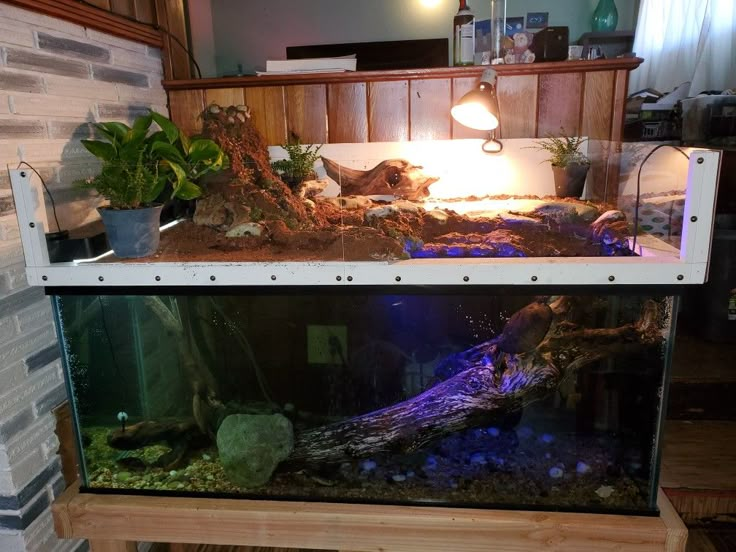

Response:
(52, 485), (687, 552)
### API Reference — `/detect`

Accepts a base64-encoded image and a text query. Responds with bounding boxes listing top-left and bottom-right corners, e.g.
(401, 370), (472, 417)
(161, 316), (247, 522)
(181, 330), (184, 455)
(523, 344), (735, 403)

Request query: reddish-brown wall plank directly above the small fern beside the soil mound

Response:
(285, 84), (328, 144)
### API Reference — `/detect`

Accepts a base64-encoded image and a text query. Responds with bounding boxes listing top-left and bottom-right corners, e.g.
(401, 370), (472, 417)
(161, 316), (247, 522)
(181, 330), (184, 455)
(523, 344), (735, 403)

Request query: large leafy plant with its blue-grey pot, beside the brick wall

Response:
(80, 111), (227, 258)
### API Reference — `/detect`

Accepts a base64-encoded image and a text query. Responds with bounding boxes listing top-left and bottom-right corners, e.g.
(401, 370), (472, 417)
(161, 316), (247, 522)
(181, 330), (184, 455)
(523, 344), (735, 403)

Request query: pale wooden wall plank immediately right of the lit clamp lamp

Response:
(498, 75), (539, 138)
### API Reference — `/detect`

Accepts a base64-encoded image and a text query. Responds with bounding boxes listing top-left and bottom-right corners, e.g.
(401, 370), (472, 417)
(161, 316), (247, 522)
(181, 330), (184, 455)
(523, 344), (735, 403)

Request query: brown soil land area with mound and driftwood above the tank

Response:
(138, 105), (631, 262)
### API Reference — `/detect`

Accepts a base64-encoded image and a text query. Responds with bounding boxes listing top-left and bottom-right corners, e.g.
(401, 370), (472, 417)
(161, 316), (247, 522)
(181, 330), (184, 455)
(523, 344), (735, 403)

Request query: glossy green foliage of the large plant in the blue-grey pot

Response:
(80, 111), (228, 209)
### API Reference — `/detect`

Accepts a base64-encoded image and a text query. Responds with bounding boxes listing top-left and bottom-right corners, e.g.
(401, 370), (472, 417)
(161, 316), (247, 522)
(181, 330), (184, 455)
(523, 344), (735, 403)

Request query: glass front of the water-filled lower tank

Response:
(55, 287), (674, 515)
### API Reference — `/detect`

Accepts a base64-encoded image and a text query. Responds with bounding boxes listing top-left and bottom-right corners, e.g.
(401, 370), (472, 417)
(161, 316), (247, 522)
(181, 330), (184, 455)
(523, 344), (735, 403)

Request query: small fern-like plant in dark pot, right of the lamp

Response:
(532, 129), (590, 197)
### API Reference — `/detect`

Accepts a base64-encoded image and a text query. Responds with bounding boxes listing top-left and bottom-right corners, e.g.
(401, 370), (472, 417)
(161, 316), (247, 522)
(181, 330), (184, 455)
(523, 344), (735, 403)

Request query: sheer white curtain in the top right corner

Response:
(629, 0), (736, 96)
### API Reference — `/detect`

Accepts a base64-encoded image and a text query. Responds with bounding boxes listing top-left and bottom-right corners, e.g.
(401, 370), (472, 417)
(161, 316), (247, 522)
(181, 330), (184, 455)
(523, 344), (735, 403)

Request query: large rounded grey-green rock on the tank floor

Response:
(217, 414), (294, 488)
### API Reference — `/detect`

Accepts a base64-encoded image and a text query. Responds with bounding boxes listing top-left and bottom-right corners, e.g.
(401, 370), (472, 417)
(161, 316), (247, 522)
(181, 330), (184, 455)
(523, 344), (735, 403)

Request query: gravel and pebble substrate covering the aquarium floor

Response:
(85, 427), (647, 511)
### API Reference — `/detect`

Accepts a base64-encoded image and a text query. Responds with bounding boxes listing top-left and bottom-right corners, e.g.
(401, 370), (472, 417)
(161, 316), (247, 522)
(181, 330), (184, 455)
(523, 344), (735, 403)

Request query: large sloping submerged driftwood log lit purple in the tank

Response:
(282, 297), (663, 469)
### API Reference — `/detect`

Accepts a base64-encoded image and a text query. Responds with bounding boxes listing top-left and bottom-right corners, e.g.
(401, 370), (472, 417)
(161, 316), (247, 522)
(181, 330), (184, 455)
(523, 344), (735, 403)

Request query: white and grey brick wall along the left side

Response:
(0, 2), (166, 552)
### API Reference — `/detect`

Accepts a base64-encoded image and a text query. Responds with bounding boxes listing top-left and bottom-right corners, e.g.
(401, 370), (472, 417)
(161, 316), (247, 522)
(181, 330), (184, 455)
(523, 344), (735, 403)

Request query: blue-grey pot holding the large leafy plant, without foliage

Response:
(97, 205), (163, 259)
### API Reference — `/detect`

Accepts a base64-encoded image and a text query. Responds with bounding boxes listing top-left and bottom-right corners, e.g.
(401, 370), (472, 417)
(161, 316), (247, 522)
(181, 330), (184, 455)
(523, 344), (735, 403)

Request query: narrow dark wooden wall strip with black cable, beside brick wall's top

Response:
(155, 0), (193, 80)
